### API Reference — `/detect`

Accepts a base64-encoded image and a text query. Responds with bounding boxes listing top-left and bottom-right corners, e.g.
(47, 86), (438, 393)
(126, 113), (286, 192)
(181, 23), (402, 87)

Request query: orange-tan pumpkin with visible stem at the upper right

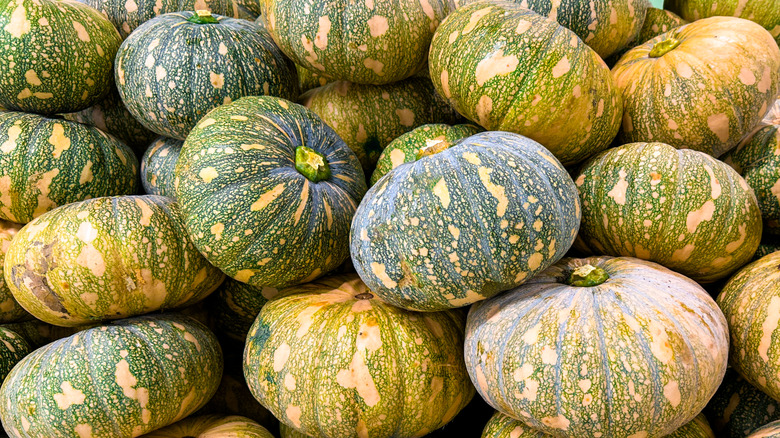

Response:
(612, 17), (780, 157)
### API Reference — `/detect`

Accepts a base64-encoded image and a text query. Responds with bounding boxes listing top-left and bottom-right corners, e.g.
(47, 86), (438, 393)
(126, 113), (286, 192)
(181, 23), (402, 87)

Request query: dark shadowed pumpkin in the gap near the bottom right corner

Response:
(704, 368), (780, 438)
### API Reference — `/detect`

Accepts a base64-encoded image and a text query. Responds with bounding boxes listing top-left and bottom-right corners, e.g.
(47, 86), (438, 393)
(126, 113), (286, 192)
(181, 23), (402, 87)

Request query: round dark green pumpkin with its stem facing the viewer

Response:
(176, 96), (366, 287)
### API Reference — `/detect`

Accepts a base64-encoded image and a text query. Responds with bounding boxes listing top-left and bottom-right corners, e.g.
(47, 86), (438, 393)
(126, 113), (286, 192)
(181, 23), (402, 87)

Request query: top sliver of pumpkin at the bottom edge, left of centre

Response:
(144, 415), (274, 438)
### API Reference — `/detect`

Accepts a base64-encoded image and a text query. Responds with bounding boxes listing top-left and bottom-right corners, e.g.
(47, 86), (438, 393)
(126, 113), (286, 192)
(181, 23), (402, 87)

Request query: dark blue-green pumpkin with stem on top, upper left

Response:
(114, 11), (299, 140)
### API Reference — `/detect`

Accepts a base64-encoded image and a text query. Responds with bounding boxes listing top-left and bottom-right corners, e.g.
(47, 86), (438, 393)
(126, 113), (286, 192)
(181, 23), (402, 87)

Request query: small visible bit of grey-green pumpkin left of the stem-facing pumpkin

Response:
(141, 137), (184, 199)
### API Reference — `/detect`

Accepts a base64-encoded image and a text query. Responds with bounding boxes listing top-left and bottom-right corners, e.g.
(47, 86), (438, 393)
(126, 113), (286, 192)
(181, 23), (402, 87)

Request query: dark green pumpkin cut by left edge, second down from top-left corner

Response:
(0, 112), (138, 224)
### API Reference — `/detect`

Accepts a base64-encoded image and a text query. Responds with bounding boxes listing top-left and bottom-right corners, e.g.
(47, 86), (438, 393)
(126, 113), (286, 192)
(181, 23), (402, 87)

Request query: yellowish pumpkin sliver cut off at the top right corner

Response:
(664, 0), (780, 45)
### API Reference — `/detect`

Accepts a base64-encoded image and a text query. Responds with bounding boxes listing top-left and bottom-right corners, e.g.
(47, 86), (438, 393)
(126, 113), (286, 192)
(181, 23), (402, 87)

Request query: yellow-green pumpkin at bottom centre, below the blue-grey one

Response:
(244, 275), (474, 438)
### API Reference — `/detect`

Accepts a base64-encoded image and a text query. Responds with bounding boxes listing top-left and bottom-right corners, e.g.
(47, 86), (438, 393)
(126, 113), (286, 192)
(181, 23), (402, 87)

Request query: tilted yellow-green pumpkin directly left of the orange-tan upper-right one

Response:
(428, 1), (623, 166)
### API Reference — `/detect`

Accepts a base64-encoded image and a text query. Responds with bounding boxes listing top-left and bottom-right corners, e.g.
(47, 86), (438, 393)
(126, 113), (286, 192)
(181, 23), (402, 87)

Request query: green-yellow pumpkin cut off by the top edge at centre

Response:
(260, 0), (450, 85)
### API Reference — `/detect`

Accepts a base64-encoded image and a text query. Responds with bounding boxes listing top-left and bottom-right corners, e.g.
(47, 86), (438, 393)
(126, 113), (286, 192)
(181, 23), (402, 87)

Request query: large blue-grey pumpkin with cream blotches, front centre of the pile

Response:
(351, 132), (580, 311)
